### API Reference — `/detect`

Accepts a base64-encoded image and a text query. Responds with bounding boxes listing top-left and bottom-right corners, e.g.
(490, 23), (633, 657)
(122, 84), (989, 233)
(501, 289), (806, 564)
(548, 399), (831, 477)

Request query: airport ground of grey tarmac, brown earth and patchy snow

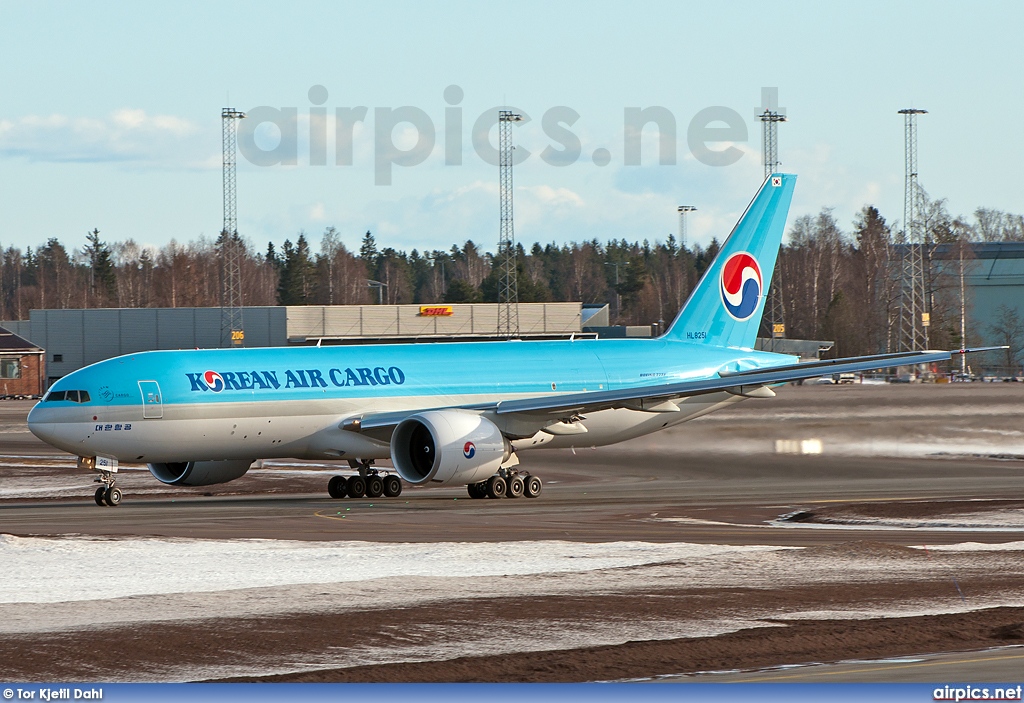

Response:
(0, 384), (1024, 682)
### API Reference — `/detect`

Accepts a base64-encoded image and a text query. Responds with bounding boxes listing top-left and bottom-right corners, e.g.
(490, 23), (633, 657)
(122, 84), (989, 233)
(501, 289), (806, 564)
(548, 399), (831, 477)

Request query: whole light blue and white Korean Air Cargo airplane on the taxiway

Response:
(28, 173), (999, 507)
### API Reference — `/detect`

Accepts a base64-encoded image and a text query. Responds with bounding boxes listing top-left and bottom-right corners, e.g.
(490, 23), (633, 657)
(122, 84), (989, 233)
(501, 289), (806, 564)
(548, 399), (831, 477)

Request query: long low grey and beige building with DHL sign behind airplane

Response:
(0, 303), (598, 382)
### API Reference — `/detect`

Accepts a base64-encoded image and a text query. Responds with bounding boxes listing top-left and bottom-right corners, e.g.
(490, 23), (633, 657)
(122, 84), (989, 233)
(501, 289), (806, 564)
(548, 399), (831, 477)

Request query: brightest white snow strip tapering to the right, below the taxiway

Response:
(0, 535), (779, 604)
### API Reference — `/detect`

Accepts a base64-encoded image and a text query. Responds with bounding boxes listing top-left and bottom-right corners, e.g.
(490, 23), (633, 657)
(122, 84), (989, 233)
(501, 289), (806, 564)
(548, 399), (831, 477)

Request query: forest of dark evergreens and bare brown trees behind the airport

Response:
(6, 196), (1024, 356)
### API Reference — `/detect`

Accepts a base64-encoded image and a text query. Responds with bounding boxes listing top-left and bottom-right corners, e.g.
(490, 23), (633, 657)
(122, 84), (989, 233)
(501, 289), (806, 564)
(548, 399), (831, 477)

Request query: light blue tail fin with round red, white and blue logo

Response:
(665, 173), (797, 348)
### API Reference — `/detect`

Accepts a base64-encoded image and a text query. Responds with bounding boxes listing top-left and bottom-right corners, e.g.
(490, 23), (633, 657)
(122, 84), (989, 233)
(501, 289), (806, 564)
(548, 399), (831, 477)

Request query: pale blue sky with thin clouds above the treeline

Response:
(0, 0), (1024, 258)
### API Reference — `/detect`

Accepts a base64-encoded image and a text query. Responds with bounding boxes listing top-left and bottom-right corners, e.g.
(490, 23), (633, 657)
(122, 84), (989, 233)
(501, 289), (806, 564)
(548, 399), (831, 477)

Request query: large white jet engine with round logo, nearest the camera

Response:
(391, 410), (512, 485)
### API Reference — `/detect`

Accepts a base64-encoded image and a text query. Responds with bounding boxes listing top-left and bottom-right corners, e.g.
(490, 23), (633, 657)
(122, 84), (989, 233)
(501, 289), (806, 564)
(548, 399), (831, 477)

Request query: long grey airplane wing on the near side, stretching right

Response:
(341, 347), (1004, 438)
